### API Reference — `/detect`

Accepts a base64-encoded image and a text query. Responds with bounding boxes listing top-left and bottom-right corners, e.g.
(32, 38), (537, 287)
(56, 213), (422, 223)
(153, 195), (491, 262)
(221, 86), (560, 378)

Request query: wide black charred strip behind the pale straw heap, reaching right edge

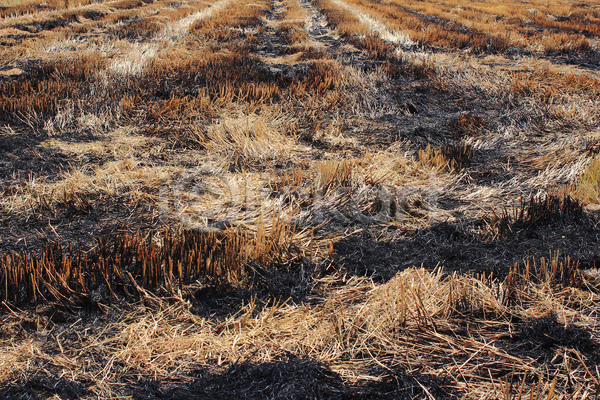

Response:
(334, 211), (600, 281)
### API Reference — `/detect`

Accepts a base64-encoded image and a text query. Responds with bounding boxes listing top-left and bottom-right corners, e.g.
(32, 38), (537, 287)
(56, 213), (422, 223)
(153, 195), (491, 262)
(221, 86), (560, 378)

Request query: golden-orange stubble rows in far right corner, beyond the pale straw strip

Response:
(336, 1), (598, 55)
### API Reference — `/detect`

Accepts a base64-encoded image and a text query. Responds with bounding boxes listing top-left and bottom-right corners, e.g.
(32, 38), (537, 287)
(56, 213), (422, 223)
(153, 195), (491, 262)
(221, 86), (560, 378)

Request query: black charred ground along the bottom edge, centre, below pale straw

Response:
(133, 357), (456, 400)
